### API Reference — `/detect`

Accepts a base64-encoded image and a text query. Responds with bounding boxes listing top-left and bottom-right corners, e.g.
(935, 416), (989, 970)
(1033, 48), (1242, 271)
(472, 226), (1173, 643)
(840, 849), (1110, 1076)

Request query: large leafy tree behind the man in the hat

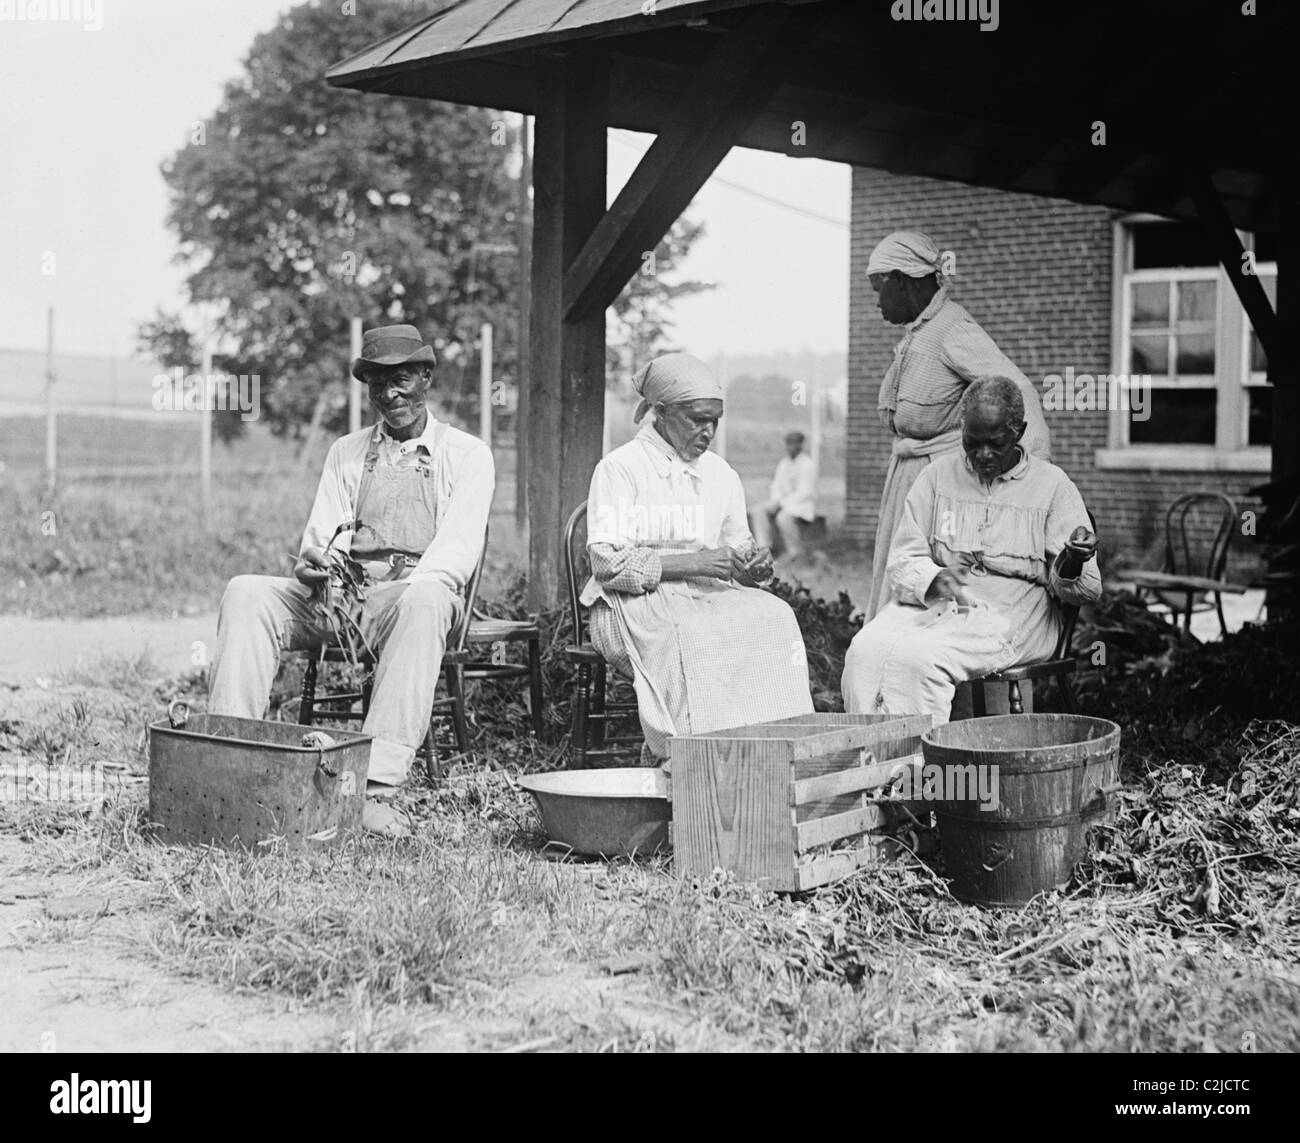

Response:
(139, 0), (519, 437)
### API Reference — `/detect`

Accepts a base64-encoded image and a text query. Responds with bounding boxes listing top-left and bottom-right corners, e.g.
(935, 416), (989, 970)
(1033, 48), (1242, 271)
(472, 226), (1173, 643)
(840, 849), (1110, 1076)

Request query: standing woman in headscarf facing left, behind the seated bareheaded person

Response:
(865, 230), (1052, 623)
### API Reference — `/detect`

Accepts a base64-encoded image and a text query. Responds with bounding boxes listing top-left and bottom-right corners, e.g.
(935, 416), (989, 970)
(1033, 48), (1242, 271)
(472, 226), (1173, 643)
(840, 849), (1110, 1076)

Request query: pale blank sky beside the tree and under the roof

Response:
(0, 0), (849, 358)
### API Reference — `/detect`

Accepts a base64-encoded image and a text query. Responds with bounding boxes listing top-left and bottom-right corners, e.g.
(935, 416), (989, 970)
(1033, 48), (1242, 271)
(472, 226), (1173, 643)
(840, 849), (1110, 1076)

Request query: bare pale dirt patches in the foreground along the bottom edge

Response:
(0, 835), (702, 1052)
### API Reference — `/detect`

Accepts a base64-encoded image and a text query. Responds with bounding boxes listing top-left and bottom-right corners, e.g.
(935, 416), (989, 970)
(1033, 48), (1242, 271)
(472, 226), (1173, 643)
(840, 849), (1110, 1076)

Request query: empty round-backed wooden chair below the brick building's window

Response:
(1128, 490), (1245, 638)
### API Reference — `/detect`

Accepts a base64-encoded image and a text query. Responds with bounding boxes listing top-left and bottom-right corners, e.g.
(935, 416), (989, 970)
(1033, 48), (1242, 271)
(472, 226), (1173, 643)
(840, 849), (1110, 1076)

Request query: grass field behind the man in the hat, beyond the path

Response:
(0, 416), (861, 616)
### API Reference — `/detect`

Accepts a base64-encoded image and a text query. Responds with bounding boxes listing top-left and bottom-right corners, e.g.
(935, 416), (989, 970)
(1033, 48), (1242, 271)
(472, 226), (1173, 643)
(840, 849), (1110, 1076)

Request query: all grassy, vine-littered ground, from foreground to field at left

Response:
(0, 408), (1300, 1052)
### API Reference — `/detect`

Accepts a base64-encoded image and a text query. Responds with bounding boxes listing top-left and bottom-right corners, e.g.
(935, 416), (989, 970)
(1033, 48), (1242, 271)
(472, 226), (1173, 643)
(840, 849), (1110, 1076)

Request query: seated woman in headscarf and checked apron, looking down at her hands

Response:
(582, 354), (813, 762)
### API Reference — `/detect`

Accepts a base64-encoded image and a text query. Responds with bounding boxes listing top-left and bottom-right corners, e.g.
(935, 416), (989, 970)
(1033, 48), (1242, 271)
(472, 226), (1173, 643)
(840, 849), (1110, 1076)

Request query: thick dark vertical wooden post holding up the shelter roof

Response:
(523, 53), (608, 609)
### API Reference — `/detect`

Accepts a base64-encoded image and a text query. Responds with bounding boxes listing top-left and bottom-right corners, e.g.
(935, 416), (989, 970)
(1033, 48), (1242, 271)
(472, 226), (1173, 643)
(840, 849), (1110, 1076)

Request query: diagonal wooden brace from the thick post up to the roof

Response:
(564, 5), (802, 321)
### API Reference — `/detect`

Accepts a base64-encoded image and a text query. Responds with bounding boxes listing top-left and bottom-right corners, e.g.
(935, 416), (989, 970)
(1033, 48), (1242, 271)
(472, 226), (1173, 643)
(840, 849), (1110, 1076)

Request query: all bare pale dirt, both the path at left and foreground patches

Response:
(0, 597), (1274, 1052)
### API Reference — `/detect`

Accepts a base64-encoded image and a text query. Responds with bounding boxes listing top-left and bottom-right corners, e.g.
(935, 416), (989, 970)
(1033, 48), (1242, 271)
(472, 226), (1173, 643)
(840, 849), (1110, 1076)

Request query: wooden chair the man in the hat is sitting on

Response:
(298, 537), (488, 782)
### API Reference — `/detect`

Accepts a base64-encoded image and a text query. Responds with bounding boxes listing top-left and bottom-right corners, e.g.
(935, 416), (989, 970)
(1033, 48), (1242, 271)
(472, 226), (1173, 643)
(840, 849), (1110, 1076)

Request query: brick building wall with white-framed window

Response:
(845, 168), (1277, 575)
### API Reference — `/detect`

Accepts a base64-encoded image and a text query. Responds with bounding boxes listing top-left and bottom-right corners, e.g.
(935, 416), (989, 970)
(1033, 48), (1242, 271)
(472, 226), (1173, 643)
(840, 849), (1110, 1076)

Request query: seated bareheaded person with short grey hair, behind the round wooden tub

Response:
(841, 377), (1101, 726)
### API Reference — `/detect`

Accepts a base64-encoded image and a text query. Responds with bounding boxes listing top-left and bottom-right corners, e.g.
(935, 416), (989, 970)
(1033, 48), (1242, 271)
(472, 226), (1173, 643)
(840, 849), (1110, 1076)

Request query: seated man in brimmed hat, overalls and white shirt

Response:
(209, 325), (495, 836)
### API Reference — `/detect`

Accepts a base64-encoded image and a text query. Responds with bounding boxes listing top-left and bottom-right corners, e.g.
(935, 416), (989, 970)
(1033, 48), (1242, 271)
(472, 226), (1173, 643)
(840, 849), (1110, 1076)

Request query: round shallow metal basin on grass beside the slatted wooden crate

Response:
(519, 767), (672, 857)
